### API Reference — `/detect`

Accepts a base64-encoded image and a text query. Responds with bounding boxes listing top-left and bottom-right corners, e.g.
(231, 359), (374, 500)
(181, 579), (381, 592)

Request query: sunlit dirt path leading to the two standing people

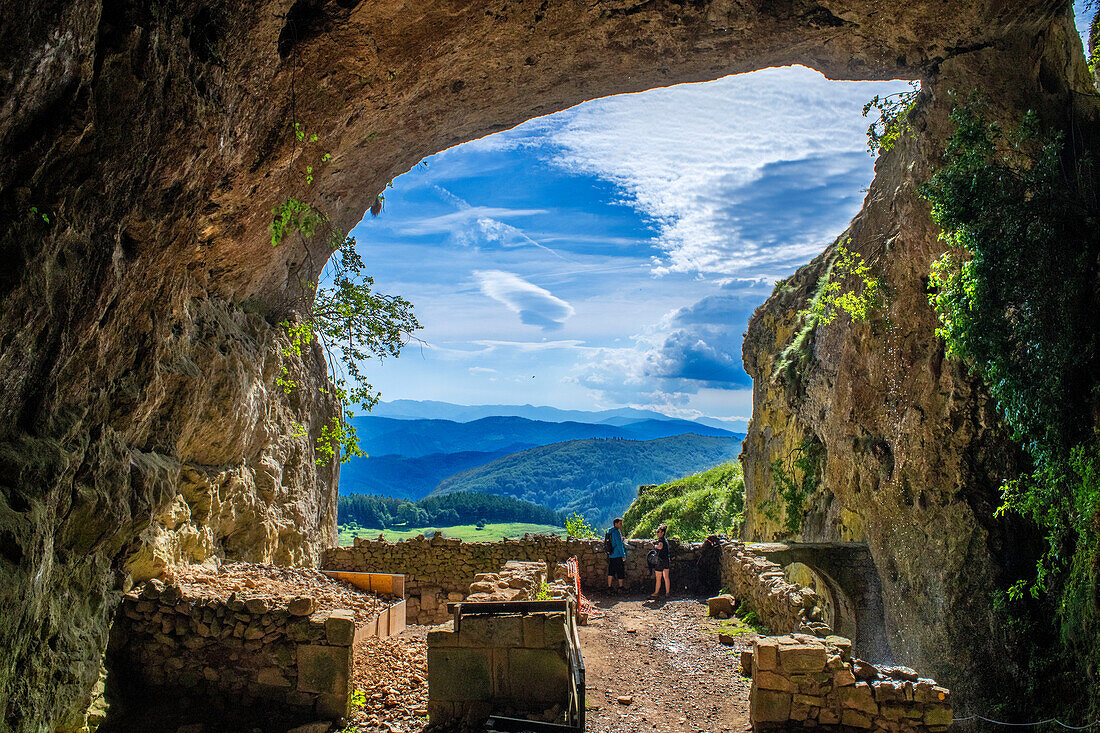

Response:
(581, 595), (754, 733)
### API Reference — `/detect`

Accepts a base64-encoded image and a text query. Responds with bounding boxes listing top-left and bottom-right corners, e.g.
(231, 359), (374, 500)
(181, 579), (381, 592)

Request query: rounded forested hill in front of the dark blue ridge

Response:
(430, 434), (741, 525)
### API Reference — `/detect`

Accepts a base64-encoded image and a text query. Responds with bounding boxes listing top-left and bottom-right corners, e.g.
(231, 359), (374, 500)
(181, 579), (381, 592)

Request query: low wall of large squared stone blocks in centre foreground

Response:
(428, 613), (579, 730)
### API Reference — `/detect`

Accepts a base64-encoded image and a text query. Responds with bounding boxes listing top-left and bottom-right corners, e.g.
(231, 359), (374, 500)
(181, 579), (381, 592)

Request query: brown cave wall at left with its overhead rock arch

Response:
(0, 0), (1084, 731)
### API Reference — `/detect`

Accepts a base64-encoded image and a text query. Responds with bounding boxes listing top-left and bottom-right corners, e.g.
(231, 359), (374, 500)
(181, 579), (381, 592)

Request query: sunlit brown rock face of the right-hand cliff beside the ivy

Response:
(741, 8), (1100, 707)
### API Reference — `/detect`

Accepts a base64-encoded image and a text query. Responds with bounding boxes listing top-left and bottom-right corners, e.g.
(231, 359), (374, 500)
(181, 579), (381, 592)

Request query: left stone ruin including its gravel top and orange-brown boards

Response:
(107, 565), (405, 726)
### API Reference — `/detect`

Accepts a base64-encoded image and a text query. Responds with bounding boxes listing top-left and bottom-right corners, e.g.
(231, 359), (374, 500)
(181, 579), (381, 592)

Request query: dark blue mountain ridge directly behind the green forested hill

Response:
(340, 408), (744, 500)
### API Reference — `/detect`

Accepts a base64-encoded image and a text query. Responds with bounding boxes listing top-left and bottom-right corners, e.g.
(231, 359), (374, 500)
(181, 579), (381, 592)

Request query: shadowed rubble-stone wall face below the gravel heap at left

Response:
(108, 582), (356, 721)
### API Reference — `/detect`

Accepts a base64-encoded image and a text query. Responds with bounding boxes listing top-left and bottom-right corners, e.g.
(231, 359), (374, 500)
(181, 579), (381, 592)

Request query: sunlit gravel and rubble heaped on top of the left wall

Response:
(164, 562), (393, 623)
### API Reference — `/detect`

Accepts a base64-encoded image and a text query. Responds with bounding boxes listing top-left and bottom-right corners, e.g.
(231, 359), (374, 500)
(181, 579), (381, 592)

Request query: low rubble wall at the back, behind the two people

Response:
(322, 535), (700, 624)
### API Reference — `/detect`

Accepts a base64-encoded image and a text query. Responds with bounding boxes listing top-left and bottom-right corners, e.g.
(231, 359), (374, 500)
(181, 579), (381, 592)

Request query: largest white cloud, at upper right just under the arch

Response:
(488, 67), (908, 274)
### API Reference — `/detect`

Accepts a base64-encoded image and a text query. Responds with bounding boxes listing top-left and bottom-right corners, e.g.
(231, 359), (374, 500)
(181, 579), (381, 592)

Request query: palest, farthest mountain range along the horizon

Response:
(371, 400), (743, 430)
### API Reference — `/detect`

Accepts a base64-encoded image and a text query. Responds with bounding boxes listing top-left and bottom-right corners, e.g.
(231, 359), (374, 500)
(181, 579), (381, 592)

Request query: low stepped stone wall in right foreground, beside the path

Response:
(743, 634), (952, 733)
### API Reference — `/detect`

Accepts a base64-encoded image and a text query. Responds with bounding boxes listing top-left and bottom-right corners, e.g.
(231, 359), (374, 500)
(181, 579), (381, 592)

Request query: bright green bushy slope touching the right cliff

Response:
(623, 460), (745, 541)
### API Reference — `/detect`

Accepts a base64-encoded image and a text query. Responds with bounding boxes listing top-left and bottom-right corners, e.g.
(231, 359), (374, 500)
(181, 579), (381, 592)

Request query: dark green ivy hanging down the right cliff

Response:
(922, 99), (1100, 708)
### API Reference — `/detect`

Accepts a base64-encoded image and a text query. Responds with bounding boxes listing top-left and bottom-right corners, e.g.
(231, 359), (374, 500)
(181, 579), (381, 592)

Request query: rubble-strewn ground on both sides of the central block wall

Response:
(350, 594), (755, 733)
